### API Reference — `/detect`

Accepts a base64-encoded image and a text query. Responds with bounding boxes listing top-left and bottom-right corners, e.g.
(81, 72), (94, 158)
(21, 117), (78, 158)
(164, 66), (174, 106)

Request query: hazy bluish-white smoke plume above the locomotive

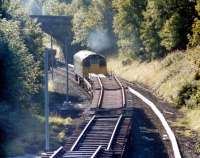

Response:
(87, 29), (112, 52)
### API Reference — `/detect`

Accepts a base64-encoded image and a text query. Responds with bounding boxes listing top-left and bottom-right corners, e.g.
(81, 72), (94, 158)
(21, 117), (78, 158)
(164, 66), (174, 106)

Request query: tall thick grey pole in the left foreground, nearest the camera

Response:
(44, 48), (49, 151)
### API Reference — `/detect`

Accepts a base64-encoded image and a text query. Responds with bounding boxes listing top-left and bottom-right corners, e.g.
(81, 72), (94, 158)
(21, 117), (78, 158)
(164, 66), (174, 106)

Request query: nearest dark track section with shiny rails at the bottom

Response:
(42, 115), (132, 158)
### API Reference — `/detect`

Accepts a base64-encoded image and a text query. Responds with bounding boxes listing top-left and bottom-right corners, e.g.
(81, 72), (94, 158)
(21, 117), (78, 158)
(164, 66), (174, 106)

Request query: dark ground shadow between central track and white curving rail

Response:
(128, 107), (169, 158)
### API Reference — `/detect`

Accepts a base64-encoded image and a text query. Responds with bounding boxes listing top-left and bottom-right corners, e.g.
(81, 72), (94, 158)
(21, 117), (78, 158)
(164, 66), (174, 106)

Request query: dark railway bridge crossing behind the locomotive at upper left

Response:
(30, 15), (80, 62)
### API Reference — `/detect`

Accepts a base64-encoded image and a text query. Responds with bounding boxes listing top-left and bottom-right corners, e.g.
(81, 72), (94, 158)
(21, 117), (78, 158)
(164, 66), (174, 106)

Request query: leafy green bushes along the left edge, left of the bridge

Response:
(0, 16), (42, 104)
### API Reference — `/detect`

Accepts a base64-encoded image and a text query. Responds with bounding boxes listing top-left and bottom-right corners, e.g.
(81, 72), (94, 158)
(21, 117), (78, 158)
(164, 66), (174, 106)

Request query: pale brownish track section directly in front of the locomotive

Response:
(91, 76), (126, 109)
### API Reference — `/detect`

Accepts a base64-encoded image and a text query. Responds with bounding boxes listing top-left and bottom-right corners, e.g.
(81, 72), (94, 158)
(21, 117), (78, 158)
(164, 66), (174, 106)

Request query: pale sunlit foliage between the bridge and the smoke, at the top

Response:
(73, 0), (112, 46)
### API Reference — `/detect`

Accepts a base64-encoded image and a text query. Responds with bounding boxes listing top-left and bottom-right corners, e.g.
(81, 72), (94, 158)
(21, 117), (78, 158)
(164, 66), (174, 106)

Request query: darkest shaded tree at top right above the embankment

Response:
(160, 0), (196, 50)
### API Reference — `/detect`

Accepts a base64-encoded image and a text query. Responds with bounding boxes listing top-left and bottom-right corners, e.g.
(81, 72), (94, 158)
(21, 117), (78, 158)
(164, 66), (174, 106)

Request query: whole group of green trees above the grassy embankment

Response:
(113, 0), (195, 60)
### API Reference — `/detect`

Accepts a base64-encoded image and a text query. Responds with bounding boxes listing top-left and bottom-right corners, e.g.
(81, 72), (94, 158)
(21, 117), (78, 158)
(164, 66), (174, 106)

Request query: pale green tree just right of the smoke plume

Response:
(113, 0), (146, 59)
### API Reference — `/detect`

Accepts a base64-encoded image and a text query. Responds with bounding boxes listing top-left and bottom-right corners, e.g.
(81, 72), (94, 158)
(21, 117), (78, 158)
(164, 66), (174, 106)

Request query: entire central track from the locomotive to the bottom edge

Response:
(42, 65), (132, 158)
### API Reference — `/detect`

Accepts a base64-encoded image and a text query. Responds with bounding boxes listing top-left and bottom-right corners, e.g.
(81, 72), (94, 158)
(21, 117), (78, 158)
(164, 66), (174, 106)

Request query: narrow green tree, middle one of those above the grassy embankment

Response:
(140, 1), (164, 60)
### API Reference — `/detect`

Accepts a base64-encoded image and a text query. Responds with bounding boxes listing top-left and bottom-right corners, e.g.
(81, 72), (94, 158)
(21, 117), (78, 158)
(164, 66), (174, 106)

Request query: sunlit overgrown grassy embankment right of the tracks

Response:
(108, 47), (200, 136)
